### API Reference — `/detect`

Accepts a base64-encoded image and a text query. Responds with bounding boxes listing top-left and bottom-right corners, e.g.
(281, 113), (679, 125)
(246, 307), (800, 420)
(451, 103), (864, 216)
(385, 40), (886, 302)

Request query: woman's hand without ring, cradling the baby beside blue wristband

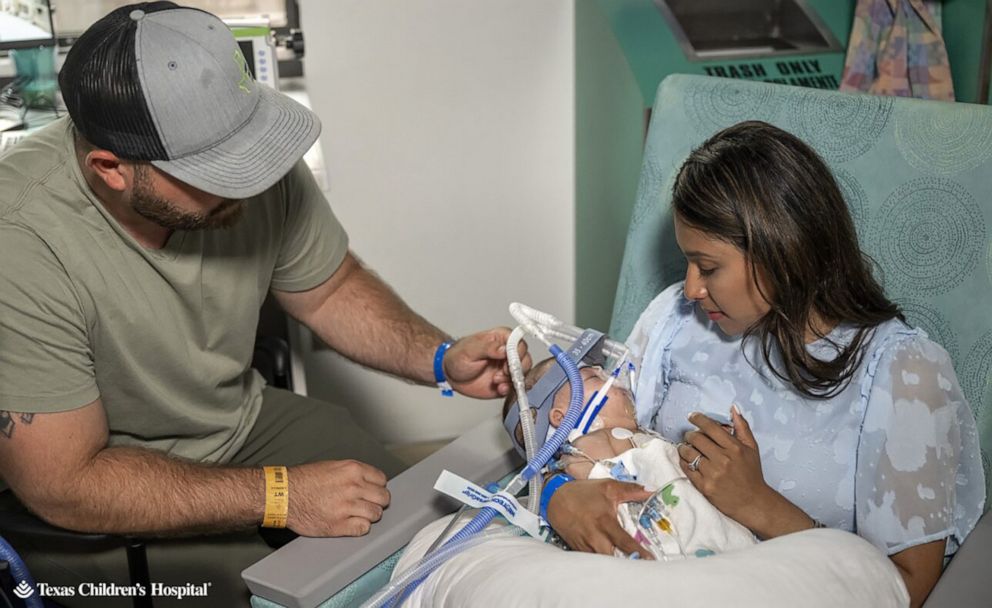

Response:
(548, 479), (652, 559)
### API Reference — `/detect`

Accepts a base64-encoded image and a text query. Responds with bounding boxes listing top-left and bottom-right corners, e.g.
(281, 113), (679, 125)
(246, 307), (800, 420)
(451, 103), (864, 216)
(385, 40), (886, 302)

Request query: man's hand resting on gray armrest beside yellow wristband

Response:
(287, 460), (389, 536)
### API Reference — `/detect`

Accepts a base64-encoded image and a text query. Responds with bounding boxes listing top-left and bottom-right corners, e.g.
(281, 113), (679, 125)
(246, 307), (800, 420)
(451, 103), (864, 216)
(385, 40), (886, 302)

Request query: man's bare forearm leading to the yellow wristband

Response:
(40, 447), (265, 536)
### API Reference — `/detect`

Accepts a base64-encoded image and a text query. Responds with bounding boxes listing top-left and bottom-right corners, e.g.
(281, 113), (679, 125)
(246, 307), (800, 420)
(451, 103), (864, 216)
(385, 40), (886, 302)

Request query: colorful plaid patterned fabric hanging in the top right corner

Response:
(840, 0), (954, 101)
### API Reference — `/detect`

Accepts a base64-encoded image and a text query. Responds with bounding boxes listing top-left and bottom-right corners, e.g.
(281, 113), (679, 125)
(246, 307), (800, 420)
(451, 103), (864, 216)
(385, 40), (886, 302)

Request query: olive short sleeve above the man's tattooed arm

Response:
(0, 224), (99, 412)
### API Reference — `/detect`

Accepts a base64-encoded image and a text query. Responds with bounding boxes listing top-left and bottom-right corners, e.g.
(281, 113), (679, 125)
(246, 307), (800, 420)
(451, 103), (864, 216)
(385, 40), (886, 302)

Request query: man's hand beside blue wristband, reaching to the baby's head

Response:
(444, 327), (531, 399)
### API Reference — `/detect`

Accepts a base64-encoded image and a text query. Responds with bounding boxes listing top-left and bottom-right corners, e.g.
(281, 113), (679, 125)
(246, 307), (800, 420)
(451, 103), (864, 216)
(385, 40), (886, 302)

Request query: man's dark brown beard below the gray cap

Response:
(131, 166), (244, 230)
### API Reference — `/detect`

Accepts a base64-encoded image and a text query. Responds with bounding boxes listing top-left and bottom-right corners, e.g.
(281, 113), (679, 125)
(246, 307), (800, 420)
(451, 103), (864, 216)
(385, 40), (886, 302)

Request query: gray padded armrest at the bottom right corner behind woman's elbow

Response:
(923, 513), (992, 608)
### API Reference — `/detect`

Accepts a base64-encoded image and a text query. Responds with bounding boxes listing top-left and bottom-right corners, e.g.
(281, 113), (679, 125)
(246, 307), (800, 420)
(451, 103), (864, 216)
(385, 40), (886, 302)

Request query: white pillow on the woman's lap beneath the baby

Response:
(395, 516), (909, 608)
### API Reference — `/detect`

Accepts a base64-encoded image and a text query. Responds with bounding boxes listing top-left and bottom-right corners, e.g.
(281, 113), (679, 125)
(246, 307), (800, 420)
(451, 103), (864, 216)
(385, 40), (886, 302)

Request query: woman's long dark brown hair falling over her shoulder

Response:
(672, 121), (903, 398)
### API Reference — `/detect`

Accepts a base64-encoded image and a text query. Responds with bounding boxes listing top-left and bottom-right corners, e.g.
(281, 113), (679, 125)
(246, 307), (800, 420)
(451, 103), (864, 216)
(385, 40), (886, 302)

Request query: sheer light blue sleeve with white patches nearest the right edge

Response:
(855, 335), (985, 555)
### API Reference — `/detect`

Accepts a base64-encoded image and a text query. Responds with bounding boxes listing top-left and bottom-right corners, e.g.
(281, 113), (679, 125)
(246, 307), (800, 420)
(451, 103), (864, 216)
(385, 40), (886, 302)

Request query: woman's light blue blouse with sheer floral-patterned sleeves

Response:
(628, 283), (985, 555)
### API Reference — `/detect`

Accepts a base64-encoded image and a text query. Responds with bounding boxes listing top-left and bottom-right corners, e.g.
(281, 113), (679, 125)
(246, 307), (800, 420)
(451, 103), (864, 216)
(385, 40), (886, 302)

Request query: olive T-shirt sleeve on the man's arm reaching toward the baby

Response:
(272, 160), (348, 291)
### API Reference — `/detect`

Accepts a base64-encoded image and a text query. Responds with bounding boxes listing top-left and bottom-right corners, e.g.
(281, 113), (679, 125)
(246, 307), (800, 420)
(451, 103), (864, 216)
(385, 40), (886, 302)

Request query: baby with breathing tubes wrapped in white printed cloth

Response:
(503, 359), (757, 560)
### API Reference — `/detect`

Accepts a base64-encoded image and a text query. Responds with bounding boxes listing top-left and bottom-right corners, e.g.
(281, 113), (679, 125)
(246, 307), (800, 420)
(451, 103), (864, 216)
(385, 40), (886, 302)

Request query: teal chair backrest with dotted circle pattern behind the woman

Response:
(610, 75), (992, 508)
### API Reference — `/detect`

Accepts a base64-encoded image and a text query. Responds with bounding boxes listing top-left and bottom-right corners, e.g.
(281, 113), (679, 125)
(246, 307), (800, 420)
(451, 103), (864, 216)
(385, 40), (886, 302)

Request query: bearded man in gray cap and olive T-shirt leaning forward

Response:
(0, 2), (529, 606)
